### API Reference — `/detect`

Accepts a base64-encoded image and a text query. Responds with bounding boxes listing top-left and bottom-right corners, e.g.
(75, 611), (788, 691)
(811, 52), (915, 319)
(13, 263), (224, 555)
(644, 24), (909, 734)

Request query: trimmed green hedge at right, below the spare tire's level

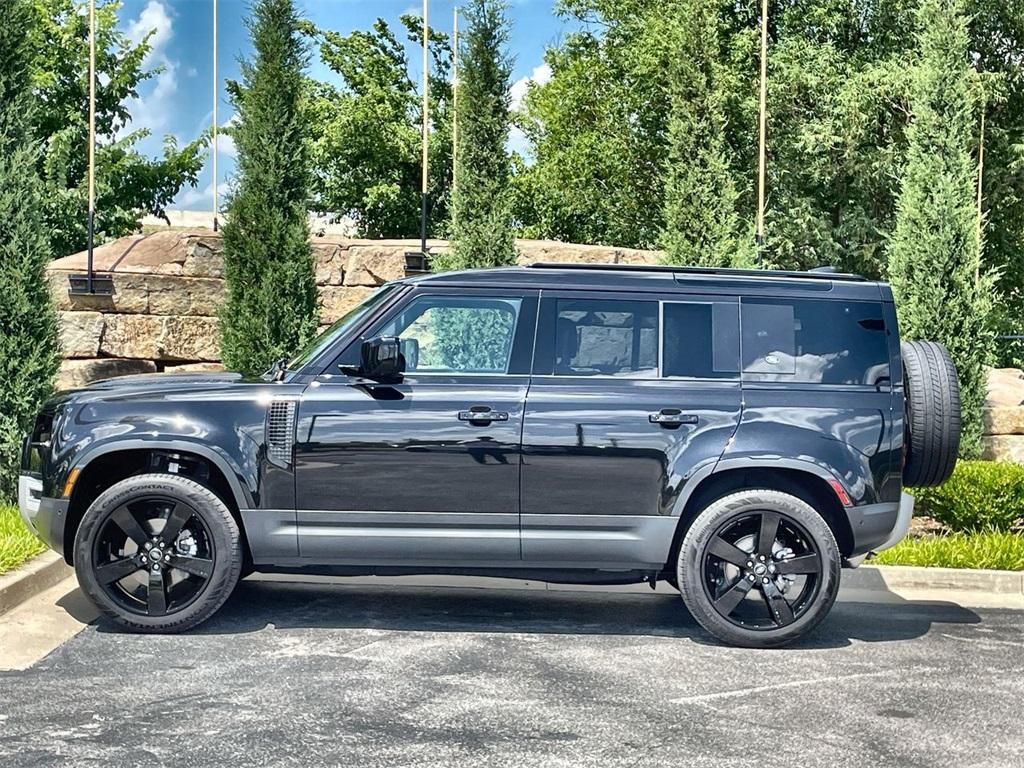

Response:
(912, 461), (1024, 530)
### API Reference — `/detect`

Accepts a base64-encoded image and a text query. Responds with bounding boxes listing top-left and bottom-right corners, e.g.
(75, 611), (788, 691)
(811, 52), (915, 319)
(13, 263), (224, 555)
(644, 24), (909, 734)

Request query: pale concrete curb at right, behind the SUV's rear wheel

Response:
(843, 565), (1024, 597)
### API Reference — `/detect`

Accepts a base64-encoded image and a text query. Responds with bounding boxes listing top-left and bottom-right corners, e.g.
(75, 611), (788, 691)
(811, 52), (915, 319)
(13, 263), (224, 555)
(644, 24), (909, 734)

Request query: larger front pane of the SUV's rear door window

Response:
(554, 299), (657, 378)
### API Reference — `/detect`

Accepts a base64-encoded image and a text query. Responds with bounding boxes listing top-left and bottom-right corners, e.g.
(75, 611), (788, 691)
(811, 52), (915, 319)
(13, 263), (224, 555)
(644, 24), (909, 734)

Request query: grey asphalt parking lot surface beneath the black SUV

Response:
(0, 581), (1024, 768)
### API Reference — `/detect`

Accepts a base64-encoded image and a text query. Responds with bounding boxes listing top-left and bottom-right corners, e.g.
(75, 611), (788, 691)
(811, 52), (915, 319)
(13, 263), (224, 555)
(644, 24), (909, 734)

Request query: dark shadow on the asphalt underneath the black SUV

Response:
(88, 577), (982, 649)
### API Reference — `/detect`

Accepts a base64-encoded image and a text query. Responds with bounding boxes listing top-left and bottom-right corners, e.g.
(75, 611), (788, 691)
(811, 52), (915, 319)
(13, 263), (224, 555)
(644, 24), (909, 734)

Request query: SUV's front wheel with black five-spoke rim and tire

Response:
(74, 474), (244, 633)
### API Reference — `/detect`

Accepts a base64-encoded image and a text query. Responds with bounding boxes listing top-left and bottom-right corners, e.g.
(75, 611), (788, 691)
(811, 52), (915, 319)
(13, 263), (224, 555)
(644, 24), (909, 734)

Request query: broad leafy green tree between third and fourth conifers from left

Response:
(513, 0), (675, 248)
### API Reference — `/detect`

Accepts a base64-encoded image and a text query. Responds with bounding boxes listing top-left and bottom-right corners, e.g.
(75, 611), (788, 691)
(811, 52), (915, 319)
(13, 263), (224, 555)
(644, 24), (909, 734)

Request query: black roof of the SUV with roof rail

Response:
(409, 263), (889, 301)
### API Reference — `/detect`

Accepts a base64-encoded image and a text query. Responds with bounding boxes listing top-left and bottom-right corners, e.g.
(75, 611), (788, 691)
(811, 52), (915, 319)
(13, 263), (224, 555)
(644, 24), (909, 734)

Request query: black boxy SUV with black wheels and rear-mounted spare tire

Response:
(19, 264), (959, 646)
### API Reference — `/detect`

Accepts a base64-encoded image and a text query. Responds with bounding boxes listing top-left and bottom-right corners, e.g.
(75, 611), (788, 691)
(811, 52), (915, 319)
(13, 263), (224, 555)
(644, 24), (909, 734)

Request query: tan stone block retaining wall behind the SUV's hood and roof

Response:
(48, 229), (658, 388)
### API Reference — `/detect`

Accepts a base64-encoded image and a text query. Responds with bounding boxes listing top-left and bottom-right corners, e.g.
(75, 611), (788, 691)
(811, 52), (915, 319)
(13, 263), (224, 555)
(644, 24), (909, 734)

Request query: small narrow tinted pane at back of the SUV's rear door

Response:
(663, 302), (739, 379)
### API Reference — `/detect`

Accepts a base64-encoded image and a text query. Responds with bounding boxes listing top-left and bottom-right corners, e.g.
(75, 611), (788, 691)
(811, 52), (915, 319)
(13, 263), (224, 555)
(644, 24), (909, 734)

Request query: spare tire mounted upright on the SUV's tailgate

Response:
(901, 341), (961, 487)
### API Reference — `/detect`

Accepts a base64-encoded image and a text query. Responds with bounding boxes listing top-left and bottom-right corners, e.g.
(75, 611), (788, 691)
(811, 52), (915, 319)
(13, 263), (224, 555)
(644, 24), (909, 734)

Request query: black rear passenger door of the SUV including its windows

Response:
(521, 291), (740, 568)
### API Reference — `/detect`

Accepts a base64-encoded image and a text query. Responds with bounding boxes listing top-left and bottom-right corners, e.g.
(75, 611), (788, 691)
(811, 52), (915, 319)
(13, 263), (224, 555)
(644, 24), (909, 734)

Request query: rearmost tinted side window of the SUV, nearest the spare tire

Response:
(740, 299), (889, 385)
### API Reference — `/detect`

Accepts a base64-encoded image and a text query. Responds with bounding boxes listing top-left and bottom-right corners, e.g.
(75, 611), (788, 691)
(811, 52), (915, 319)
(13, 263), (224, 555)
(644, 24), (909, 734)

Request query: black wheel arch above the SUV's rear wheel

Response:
(666, 459), (854, 570)
